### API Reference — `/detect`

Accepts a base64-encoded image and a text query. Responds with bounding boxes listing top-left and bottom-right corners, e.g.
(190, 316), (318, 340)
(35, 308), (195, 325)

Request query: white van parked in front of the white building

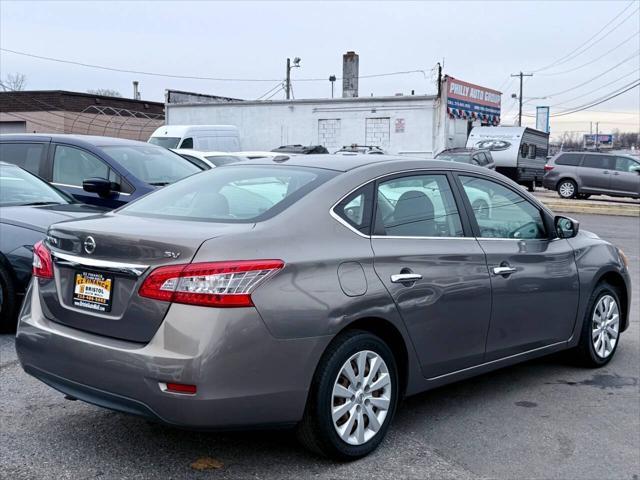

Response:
(149, 125), (240, 152)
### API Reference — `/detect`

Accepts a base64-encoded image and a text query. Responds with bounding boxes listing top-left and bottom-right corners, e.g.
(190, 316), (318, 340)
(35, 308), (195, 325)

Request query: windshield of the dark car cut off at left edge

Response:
(0, 165), (71, 207)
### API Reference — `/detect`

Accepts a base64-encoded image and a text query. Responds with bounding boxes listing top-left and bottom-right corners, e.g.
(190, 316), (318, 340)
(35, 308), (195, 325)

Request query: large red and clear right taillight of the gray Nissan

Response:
(138, 260), (284, 307)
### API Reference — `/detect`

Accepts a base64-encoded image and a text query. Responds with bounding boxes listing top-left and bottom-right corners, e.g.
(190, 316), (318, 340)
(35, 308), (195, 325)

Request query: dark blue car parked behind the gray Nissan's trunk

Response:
(0, 134), (202, 208)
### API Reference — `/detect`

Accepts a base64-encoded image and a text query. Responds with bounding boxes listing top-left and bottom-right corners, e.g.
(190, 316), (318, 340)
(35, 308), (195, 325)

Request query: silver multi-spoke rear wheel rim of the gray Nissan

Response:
(331, 350), (392, 445)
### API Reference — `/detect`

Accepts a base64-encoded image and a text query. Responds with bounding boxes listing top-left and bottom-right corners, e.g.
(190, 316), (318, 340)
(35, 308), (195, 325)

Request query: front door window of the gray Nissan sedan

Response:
(460, 176), (547, 239)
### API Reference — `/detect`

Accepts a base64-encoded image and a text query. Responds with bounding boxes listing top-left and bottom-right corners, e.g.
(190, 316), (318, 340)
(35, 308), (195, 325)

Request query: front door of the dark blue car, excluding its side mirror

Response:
(51, 145), (128, 208)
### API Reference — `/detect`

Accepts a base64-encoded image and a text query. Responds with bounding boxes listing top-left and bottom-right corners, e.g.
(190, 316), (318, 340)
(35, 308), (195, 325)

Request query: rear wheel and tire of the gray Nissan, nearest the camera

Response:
(298, 330), (398, 461)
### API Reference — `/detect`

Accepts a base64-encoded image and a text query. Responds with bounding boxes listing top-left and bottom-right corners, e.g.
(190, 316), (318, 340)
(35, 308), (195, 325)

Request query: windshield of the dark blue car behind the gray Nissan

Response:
(102, 145), (202, 186)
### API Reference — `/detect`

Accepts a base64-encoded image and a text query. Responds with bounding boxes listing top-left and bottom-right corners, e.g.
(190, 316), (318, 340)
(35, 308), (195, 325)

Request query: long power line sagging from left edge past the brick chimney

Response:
(0, 48), (427, 82)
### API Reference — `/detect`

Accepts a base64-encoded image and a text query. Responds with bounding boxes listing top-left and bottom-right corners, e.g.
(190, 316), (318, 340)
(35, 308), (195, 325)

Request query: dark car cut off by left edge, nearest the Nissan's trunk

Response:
(0, 162), (105, 330)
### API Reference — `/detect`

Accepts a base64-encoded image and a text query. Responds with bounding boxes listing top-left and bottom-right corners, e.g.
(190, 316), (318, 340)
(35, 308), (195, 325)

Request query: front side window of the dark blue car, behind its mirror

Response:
(53, 145), (109, 187)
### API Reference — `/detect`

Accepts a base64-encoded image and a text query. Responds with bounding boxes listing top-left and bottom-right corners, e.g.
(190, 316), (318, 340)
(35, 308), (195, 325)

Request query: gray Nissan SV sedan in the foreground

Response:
(16, 155), (630, 459)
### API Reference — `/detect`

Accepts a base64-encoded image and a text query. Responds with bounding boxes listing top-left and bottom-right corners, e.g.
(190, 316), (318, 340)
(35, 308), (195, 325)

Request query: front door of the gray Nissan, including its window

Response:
(458, 174), (579, 361)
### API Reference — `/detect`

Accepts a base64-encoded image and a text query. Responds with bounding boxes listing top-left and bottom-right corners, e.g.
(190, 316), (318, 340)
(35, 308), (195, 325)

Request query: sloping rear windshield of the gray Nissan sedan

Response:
(118, 165), (336, 223)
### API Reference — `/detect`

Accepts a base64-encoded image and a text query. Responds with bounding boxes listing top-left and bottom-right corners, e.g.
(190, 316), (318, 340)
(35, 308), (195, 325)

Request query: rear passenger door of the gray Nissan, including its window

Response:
(371, 173), (491, 378)
